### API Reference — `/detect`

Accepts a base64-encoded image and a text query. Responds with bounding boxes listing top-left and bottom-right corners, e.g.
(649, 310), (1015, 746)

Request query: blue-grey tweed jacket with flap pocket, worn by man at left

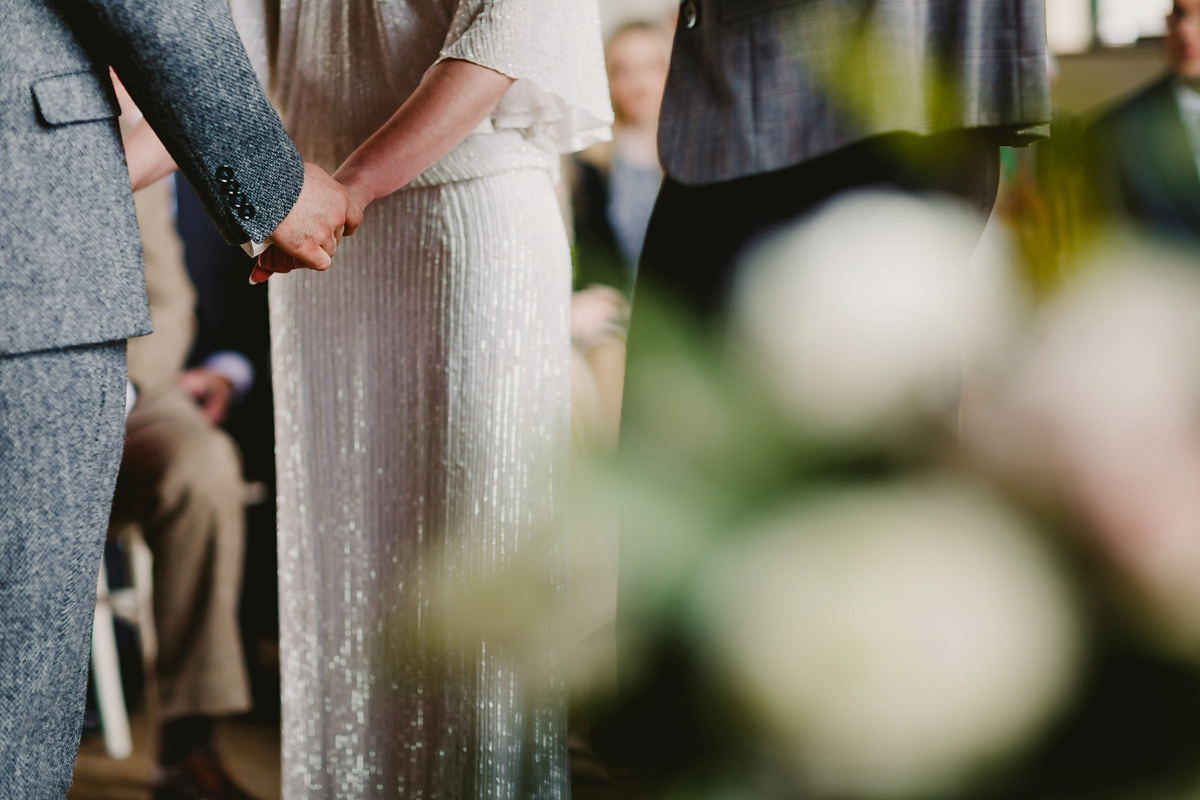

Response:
(0, 0), (304, 355)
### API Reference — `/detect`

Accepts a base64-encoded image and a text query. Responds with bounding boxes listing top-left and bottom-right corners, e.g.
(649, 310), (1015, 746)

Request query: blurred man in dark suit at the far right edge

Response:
(1087, 0), (1200, 247)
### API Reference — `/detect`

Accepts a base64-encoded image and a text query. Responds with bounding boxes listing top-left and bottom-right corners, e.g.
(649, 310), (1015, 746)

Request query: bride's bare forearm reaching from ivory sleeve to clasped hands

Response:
(334, 59), (512, 207)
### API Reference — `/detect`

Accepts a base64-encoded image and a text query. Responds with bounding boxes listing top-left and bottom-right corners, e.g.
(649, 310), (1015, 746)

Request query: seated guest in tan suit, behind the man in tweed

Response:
(113, 87), (260, 800)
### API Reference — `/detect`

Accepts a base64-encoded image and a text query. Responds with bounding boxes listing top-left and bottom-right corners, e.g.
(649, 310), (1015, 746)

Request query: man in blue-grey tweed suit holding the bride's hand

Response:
(0, 0), (361, 800)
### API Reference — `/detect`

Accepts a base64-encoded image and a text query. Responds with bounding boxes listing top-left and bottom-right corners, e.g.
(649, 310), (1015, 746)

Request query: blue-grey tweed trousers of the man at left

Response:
(0, 341), (125, 800)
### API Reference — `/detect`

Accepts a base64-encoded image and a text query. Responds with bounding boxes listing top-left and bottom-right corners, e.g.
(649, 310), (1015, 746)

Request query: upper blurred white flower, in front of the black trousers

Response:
(733, 193), (1012, 439)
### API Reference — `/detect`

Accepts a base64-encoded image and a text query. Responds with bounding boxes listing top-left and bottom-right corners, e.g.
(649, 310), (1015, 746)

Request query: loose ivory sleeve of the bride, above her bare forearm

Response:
(438, 0), (612, 152)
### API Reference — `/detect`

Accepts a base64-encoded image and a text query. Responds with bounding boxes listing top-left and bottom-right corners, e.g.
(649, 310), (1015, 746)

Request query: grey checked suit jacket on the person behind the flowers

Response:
(659, 0), (1050, 185)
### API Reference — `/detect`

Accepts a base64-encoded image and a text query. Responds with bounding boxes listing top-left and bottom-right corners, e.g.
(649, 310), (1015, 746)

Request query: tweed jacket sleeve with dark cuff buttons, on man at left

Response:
(71, 0), (304, 242)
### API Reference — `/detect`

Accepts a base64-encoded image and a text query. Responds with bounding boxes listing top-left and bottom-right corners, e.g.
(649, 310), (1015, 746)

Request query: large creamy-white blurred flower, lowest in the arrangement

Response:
(697, 482), (1082, 798)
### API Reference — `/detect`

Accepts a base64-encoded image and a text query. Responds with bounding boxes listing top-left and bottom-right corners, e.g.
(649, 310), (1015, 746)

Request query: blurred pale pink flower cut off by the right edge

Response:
(967, 243), (1200, 651)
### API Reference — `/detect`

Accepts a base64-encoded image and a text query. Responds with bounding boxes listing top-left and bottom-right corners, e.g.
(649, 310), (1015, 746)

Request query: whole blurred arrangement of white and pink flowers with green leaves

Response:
(424, 158), (1200, 800)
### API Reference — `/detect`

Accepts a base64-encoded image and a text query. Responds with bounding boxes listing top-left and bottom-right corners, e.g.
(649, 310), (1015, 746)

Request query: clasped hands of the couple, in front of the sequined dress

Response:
(258, 163), (367, 283)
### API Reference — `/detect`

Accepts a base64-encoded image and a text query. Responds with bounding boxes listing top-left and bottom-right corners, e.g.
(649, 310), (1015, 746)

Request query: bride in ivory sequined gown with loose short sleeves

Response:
(232, 0), (611, 800)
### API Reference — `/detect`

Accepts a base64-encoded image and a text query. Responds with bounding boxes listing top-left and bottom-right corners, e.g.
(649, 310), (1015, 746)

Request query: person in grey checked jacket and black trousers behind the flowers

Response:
(634, 0), (1050, 319)
